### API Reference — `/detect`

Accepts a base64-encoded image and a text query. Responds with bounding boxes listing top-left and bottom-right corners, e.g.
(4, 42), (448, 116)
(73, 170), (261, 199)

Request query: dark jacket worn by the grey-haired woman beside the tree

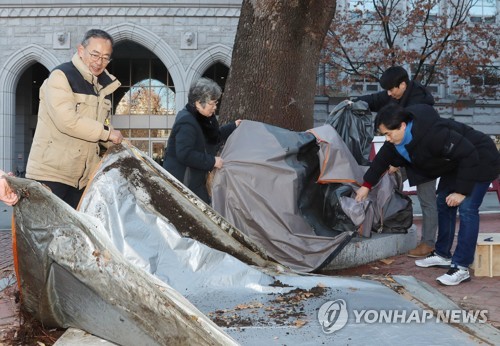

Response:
(163, 105), (236, 203)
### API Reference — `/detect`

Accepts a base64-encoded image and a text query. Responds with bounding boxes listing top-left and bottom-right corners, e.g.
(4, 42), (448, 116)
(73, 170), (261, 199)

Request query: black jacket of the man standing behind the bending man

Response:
(357, 81), (434, 112)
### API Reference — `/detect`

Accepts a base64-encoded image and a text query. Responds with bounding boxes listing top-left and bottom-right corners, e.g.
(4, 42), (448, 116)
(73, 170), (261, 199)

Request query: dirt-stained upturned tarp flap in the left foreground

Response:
(11, 171), (240, 345)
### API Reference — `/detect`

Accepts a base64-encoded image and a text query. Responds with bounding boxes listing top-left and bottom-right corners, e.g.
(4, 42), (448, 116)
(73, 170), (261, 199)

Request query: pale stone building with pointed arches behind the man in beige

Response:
(0, 0), (500, 174)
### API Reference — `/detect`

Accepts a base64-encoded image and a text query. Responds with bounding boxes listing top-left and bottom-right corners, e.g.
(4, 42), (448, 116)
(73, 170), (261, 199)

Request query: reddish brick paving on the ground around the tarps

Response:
(0, 193), (500, 346)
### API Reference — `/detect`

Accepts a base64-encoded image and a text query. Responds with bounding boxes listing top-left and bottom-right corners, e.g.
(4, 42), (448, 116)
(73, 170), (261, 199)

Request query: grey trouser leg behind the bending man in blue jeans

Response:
(417, 180), (438, 247)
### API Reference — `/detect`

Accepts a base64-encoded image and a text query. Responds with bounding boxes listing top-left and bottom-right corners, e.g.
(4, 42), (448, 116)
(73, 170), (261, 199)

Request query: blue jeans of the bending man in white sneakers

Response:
(434, 183), (490, 268)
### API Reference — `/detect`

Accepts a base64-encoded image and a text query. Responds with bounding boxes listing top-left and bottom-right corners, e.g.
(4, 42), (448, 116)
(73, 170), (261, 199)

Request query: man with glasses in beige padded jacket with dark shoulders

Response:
(26, 29), (123, 208)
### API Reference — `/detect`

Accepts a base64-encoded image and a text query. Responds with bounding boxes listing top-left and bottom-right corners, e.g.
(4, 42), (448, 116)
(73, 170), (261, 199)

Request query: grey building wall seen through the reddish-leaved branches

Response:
(315, 0), (500, 139)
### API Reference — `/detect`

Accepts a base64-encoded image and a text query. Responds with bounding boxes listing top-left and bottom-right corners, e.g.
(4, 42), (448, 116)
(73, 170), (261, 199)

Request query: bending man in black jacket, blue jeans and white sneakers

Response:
(356, 105), (500, 285)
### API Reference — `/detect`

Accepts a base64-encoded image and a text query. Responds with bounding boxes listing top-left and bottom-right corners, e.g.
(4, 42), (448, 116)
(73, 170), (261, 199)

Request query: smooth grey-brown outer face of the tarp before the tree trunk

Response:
(212, 121), (352, 271)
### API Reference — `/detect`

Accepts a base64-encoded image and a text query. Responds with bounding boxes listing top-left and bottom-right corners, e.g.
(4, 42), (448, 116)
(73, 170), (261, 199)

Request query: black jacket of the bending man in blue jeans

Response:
(364, 105), (500, 195)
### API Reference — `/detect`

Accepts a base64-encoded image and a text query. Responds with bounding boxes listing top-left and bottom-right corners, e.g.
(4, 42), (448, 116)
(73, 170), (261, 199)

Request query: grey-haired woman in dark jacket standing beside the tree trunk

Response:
(163, 78), (241, 203)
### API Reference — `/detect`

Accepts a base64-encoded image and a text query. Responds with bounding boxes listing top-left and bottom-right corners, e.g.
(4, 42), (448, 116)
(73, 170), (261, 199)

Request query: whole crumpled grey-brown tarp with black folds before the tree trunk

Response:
(212, 121), (412, 272)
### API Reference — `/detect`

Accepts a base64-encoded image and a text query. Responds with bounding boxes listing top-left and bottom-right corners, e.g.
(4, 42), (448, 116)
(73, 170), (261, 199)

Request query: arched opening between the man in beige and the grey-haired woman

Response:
(108, 41), (176, 159)
